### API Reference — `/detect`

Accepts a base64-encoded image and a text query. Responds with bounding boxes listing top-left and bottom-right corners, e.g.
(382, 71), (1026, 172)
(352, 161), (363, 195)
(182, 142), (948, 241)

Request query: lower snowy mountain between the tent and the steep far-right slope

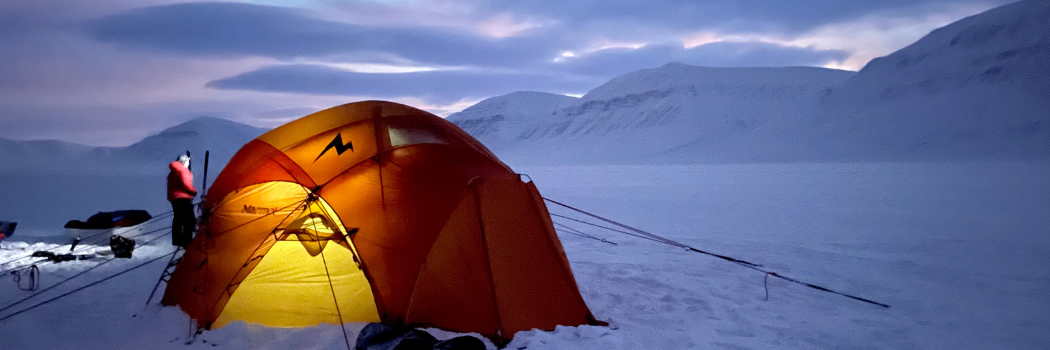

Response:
(449, 63), (853, 163)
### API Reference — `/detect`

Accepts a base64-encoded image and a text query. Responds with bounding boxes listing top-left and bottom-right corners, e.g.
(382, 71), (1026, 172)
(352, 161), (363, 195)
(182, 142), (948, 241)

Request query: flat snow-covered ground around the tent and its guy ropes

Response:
(0, 163), (1050, 350)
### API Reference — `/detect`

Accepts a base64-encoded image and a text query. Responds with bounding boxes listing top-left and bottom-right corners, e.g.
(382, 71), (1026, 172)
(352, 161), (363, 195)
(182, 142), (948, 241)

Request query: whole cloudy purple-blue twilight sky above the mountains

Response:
(0, 0), (1010, 146)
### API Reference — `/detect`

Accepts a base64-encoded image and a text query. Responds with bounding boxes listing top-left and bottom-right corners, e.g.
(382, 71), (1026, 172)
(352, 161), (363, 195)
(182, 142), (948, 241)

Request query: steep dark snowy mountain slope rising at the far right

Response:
(793, 0), (1050, 160)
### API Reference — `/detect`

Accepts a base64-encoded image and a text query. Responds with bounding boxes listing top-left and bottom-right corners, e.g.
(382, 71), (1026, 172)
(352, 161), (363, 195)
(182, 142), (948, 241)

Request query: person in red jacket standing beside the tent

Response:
(168, 155), (196, 247)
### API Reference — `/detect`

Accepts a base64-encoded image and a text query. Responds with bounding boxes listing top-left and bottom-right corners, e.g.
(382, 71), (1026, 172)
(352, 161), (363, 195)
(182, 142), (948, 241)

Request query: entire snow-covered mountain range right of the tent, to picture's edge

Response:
(449, 0), (1050, 164)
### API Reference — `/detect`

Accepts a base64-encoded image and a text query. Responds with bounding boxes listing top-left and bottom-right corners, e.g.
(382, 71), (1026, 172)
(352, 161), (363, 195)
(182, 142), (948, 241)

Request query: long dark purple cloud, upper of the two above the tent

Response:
(86, 3), (567, 66)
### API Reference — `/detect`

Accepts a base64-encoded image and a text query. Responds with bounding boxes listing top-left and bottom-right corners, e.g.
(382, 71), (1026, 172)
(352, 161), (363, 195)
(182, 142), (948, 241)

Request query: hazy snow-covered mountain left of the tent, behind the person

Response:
(0, 117), (266, 230)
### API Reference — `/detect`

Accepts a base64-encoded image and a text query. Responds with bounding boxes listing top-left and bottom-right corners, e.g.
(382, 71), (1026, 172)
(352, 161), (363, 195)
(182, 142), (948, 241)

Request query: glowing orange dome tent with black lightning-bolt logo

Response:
(163, 101), (599, 339)
